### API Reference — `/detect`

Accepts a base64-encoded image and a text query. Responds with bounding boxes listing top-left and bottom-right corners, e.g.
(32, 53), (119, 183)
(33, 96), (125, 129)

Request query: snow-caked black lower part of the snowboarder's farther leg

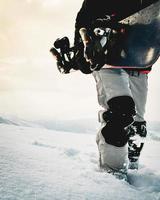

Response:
(128, 121), (147, 169)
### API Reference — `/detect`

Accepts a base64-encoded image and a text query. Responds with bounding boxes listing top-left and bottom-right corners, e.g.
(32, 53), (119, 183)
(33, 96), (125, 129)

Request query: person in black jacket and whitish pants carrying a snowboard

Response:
(74, 0), (160, 171)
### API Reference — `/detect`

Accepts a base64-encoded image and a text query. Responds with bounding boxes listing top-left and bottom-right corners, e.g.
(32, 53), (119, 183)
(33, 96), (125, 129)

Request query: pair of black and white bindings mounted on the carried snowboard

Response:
(50, 25), (111, 74)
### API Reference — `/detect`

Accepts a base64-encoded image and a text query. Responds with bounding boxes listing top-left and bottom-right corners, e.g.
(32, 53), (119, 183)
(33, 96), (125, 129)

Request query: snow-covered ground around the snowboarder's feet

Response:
(0, 123), (160, 200)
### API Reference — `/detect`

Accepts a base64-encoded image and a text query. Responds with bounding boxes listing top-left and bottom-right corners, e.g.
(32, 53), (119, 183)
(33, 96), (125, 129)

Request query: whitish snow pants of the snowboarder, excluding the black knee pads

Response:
(93, 68), (148, 170)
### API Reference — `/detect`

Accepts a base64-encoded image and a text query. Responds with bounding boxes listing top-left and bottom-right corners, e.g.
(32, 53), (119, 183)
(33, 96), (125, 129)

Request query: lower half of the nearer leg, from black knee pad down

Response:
(97, 96), (135, 171)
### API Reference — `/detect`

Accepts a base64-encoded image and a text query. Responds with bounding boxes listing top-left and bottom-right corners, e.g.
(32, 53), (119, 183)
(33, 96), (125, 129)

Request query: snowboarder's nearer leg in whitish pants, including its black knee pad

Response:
(93, 69), (135, 171)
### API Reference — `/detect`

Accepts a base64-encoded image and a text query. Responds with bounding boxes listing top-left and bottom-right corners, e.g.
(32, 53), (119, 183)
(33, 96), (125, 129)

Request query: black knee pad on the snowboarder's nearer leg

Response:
(102, 96), (136, 147)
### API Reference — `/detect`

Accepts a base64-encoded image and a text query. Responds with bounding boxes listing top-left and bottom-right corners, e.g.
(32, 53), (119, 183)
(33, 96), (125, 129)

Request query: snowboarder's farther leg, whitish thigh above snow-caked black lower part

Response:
(128, 74), (148, 169)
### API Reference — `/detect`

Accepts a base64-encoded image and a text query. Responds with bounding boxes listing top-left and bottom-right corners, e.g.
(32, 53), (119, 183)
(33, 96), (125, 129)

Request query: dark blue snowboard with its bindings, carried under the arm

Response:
(50, 0), (160, 73)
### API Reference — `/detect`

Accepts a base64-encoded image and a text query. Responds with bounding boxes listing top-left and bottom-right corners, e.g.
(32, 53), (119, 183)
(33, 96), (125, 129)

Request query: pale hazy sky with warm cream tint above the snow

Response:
(0, 0), (160, 120)
